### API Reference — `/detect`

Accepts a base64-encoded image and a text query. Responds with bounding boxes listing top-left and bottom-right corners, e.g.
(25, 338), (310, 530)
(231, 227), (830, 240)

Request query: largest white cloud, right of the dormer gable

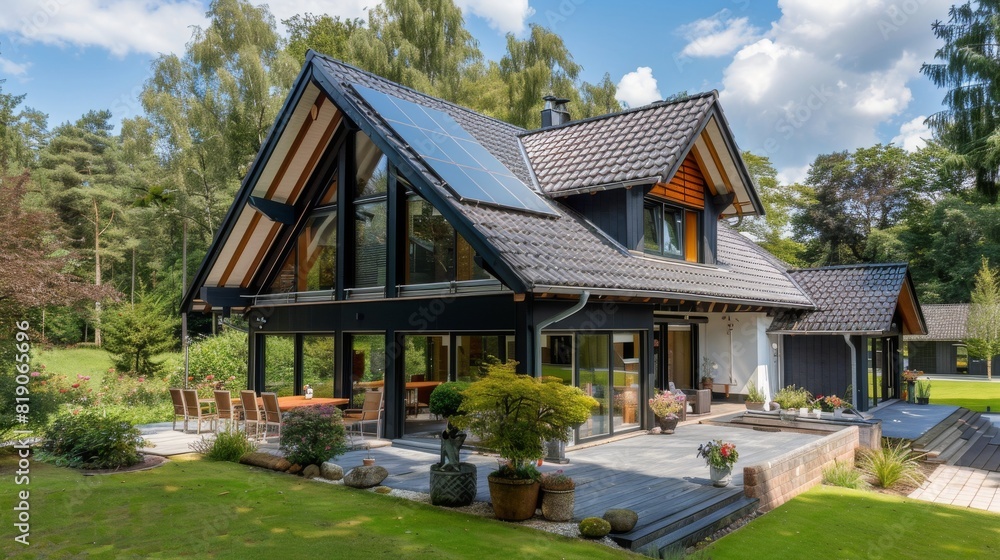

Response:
(712, 0), (952, 171)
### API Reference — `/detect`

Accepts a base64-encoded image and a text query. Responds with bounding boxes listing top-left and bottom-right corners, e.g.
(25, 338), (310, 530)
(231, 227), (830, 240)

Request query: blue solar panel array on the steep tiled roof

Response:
(354, 85), (555, 215)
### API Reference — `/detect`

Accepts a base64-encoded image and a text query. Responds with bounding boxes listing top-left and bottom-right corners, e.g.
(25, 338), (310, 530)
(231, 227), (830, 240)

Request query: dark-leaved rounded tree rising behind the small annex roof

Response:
(793, 144), (915, 264)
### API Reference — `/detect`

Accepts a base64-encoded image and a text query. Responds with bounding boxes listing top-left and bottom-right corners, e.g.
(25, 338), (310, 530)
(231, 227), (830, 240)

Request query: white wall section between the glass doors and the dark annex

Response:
(698, 313), (780, 395)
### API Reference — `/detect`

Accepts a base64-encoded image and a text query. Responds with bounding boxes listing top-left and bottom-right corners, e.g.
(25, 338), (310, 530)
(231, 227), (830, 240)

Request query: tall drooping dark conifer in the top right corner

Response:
(920, 0), (1000, 204)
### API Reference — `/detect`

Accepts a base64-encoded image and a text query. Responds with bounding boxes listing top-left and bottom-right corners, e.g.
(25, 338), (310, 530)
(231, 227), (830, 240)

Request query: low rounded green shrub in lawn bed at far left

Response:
(42, 409), (147, 469)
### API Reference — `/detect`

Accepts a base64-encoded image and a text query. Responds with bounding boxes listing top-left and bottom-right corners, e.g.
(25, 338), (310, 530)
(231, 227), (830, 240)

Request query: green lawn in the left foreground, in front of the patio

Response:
(0, 454), (634, 559)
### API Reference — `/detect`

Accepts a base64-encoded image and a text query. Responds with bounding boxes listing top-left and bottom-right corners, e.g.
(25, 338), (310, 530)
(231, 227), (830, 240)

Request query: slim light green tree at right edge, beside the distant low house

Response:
(965, 257), (1000, 380)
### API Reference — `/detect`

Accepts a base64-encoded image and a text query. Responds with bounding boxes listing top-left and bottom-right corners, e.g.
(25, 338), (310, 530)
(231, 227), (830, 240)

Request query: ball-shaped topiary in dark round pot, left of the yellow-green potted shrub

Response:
(428, 381), (477, 507)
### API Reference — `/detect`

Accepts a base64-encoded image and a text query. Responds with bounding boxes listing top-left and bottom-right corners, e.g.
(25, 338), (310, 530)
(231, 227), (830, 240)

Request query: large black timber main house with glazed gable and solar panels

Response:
(183, 52), (922, 441)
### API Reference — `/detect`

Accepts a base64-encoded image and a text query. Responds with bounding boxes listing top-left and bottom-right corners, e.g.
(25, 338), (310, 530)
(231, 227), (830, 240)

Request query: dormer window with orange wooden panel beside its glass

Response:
(642, 200), (701, 262)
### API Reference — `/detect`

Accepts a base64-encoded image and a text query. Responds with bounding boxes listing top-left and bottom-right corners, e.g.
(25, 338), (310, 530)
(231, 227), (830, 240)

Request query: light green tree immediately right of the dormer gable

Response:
(738, 152), (804, 266)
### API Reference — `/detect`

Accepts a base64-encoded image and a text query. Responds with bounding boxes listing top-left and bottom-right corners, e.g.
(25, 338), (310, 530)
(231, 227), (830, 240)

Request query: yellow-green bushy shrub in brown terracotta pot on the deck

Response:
(451, 358), (599, 521)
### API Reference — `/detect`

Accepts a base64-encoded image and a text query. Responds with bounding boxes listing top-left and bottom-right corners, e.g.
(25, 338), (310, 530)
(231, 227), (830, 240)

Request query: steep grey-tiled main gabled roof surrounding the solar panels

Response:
(185, 52), (813, 308)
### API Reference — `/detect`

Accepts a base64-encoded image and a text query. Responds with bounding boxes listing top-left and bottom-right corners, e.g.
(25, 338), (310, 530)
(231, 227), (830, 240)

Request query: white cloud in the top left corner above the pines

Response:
(0, 0), (206, 57)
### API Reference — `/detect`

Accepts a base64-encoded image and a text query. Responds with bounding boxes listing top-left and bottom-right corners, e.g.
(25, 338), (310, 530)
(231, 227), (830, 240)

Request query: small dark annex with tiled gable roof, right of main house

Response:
(768, 264), (927, 410)
